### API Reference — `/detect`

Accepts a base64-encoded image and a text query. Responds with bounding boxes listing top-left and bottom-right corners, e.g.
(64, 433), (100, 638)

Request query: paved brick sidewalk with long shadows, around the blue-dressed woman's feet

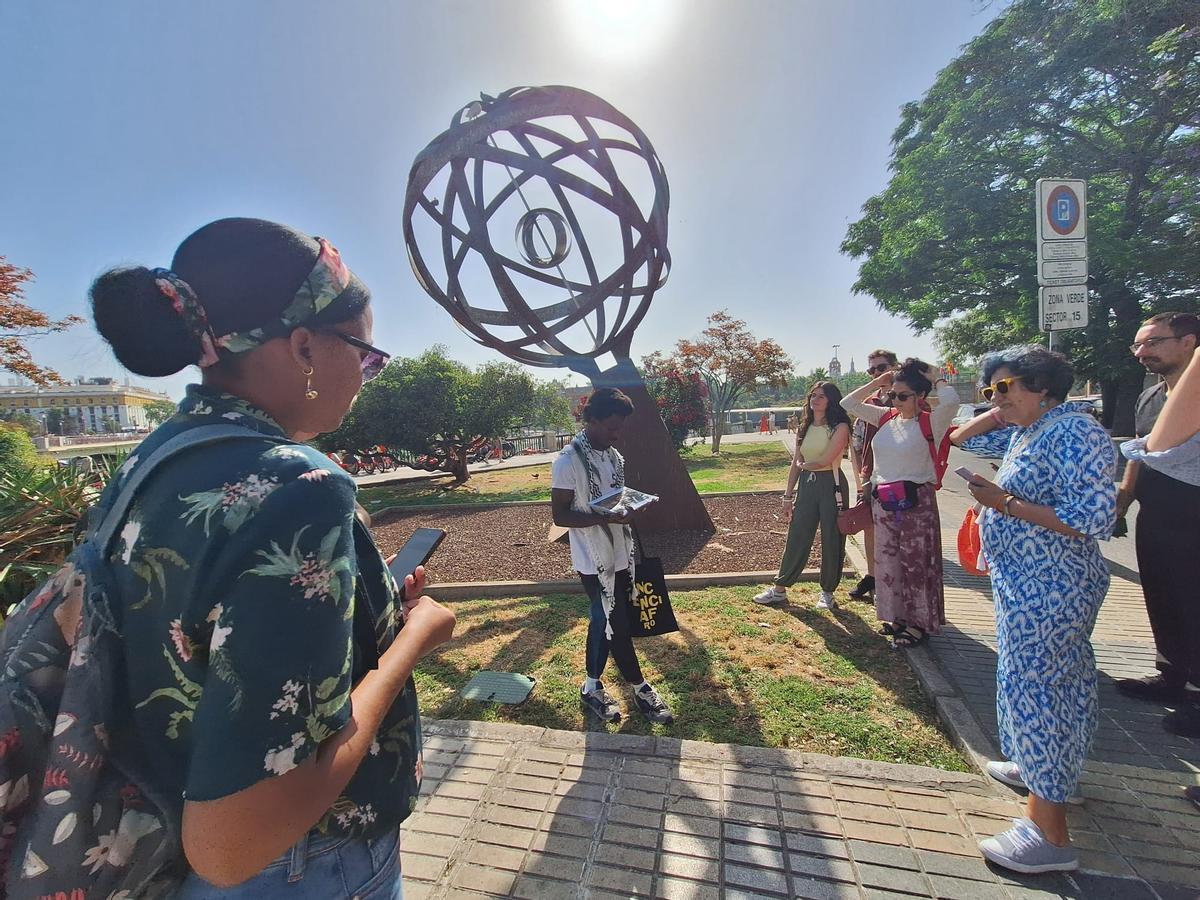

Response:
(403, 448), (1200, 900)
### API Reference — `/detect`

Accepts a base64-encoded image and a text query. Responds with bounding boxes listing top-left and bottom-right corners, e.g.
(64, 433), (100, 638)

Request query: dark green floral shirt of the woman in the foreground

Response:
(110, 385), (421, 835)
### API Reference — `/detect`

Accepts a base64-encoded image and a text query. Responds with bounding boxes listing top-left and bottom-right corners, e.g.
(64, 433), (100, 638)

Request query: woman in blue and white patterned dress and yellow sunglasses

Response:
(950, 346), (1116, 872)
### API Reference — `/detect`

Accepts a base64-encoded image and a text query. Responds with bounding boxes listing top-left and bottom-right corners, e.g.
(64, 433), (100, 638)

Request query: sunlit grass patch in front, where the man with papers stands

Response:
(416, 584), (968, 772)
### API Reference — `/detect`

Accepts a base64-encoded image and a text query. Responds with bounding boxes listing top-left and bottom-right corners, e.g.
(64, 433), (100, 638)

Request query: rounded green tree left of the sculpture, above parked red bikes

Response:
(317, 346), (539, 481)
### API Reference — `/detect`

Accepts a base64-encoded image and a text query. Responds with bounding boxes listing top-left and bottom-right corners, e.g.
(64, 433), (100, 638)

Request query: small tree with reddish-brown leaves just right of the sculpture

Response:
(642, 310), (792, 454)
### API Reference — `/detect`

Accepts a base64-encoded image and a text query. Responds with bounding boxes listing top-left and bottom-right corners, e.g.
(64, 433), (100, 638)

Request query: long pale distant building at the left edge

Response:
(0, 377), (174, 432)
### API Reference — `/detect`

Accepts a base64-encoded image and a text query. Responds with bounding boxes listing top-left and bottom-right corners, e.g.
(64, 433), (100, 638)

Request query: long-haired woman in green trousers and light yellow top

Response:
(754, 382), (850, 610)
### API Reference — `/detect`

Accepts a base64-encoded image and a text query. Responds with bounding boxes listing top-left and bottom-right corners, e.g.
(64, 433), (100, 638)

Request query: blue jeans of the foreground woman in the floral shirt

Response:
(175, 827), (401, 900)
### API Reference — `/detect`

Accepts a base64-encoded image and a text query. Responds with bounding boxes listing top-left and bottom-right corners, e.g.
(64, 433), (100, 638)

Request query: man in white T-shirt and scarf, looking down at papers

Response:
(551, 388), (674, 725)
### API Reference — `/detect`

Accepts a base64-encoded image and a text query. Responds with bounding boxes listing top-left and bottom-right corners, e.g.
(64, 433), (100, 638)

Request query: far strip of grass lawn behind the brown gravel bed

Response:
(359, 443), (788, 512)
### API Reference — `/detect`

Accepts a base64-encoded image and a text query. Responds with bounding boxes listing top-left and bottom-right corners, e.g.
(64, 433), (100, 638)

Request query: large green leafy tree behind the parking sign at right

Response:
(842, 0), (1200, 432)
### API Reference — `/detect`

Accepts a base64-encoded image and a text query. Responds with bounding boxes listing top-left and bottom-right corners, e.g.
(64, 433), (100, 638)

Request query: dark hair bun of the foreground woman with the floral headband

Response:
(89, 265), (200, 378)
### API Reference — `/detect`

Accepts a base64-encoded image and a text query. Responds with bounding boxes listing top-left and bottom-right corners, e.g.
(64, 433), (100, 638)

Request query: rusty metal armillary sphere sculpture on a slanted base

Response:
(404, 85), (713, 530)
